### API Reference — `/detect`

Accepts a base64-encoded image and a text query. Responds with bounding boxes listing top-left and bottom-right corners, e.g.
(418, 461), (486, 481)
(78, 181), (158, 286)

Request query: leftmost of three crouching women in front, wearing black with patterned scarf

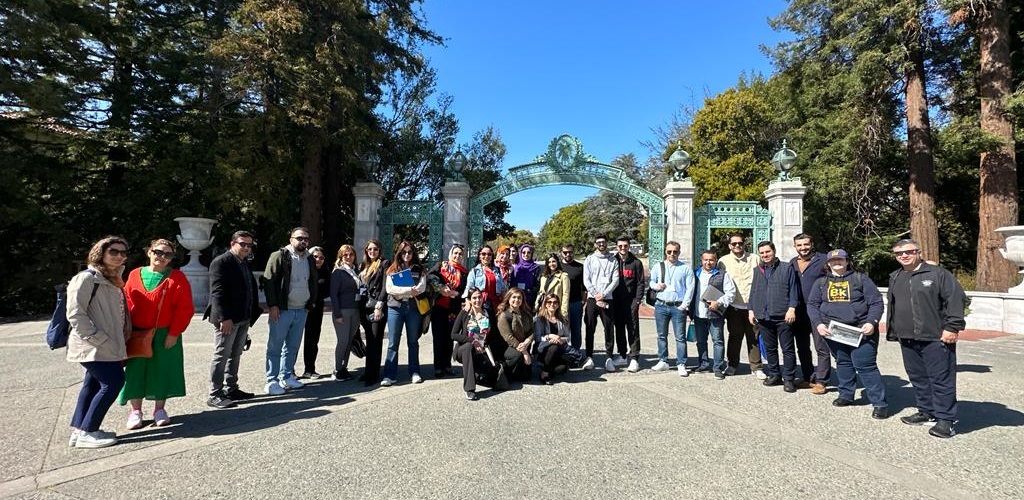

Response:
(452, 287), (501, 401)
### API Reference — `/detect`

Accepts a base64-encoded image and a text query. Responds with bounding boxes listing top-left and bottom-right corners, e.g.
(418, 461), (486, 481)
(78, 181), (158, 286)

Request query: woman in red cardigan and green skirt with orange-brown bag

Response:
(120, 239), (195, 429)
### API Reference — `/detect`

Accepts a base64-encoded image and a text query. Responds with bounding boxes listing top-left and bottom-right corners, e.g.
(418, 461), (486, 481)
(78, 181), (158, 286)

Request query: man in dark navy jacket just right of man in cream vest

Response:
(749, 241), (800, 392)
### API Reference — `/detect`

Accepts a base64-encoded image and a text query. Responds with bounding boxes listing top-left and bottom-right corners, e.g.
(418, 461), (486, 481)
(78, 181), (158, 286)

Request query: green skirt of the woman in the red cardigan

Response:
(119, 328), (185, 405)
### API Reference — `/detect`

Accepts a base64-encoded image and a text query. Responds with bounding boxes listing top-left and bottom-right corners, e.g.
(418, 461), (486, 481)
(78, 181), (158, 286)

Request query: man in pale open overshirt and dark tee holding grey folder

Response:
(690, 249), (736, 380)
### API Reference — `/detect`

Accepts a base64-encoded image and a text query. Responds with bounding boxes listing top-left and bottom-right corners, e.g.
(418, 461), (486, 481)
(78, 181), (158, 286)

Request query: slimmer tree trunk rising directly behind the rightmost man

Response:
(906, 39), (939, 262)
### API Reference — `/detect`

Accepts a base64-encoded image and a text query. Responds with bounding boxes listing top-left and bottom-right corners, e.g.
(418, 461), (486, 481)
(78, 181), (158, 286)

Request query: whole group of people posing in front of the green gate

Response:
(67, 227), (966, 448)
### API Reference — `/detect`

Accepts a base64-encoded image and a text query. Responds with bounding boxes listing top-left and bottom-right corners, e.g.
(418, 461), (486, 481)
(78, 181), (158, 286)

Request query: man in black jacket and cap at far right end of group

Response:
(886, 240), (967, 438)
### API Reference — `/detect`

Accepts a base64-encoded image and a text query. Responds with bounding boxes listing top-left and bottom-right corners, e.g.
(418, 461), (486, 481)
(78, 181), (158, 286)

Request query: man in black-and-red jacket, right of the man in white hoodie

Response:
(611, 236), (647, 373)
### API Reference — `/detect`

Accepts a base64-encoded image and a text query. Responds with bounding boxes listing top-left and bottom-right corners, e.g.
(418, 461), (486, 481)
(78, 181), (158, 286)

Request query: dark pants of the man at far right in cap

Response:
(899, 339), (957, 421)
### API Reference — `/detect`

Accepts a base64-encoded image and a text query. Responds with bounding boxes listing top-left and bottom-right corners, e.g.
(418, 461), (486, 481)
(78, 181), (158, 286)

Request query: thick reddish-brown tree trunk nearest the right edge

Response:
(977, 0), (1018, 292)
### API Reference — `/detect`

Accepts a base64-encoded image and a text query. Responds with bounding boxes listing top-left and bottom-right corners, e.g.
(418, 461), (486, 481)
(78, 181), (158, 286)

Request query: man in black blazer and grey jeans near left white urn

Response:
(203, 231), (260, 408)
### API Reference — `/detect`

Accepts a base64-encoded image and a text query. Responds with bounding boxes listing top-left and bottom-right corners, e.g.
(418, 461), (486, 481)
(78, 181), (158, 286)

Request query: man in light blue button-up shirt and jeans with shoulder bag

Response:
(650, 242), (693, 377)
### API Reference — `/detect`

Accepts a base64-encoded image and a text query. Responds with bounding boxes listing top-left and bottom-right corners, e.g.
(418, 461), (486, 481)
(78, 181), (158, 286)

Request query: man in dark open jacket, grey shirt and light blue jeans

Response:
(263, 227), (317, 395)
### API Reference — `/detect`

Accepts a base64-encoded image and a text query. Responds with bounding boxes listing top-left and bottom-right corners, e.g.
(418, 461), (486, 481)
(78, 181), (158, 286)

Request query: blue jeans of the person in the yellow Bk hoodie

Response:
(825, 334), (889, 407)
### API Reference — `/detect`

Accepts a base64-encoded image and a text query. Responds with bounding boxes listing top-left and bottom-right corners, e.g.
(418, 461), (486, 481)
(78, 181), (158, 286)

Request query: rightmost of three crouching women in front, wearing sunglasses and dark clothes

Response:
(534, 293), (582, 385)
